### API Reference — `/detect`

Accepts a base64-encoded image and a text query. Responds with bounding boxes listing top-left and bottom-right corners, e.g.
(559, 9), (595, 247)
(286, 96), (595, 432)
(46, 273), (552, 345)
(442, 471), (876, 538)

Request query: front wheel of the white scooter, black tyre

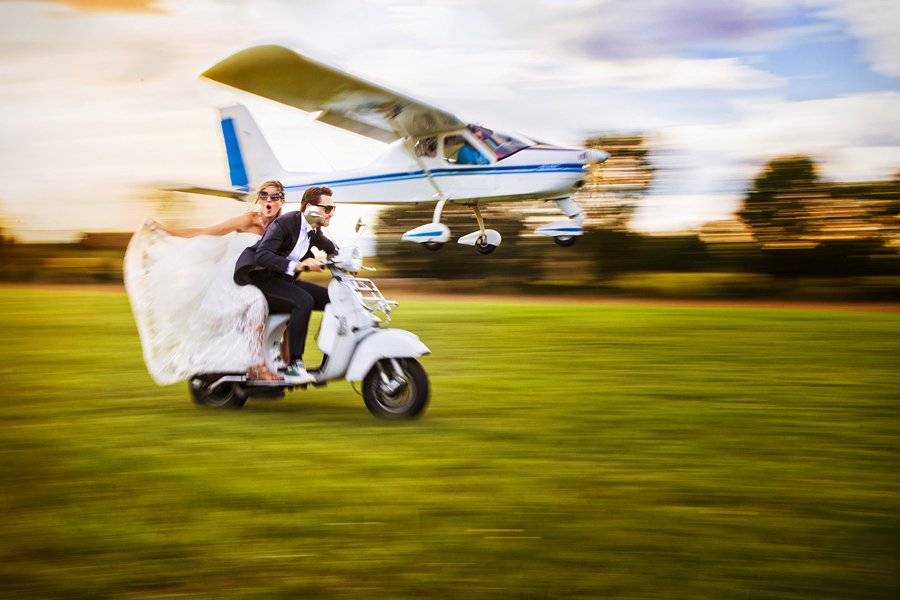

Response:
(363, 358), (430, 419)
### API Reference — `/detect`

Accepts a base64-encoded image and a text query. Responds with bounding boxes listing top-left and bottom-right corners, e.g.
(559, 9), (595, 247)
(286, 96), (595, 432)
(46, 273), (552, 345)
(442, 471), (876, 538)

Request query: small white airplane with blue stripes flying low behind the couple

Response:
(192, 45), (609, 254)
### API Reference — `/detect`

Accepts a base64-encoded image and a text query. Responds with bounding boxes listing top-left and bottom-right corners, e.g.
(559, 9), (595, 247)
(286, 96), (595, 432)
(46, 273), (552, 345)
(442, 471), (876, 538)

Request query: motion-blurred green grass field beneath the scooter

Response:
(0, 288), (900, 599)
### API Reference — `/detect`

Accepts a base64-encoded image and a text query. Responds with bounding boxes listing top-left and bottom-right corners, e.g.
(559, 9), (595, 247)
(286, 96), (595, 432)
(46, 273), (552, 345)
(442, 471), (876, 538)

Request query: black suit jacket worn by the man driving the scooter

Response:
(234, 211), (338, 285)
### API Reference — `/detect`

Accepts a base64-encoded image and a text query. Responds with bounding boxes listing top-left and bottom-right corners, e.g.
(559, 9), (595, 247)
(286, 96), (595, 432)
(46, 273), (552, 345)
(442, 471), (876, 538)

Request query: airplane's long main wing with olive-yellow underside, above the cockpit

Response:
(202, 45), (465, 142)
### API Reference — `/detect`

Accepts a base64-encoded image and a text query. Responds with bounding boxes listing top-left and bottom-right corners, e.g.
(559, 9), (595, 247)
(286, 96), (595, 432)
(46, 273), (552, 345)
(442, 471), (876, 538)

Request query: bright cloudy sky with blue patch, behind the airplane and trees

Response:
(0, 0), (900, 239)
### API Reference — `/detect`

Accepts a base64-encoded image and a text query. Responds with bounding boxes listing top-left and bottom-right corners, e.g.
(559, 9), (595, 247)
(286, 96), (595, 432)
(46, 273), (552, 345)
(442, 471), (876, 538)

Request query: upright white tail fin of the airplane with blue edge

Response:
(219, 104), (287, 191)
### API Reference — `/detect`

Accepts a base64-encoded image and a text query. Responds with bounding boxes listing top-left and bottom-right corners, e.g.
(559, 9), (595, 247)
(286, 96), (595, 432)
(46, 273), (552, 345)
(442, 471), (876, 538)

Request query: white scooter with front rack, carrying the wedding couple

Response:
(188, 218), (430, 419)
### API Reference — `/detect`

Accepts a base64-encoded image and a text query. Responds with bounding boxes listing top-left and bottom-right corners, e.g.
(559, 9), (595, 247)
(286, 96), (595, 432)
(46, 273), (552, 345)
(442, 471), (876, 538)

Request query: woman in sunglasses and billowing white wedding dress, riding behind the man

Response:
(124, 181), (284, 385)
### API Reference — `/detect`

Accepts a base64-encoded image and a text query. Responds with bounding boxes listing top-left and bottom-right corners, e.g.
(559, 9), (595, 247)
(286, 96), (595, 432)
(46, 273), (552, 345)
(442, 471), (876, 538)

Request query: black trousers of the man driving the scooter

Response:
(250, 271), (328, 362)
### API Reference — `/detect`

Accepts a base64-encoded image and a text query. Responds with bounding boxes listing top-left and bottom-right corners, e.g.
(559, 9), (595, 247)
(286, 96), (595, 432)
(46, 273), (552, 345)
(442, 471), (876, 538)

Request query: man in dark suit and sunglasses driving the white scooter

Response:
(234, 187), (338, 384)
